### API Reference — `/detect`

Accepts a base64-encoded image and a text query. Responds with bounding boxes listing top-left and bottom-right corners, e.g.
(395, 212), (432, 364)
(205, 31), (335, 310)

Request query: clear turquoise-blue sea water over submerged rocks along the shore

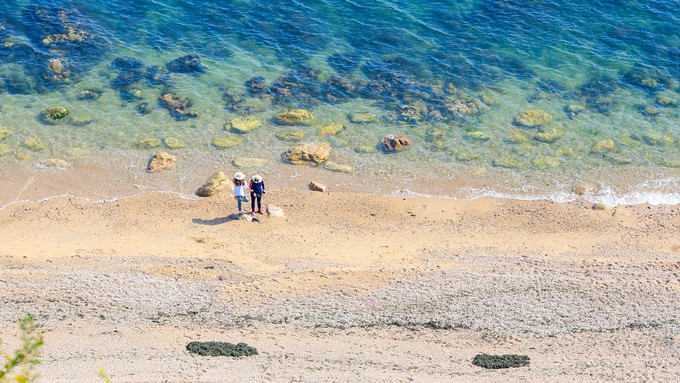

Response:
(0, 0), (680, 203)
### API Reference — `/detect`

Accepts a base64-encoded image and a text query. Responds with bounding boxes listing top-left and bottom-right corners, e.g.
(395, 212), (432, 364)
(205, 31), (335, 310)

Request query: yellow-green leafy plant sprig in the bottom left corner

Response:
(0, 315), (43, 383)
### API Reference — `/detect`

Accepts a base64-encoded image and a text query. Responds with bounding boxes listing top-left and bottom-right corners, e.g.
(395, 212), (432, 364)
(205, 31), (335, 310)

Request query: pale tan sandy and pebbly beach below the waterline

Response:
(0, 191), (680, 383)
